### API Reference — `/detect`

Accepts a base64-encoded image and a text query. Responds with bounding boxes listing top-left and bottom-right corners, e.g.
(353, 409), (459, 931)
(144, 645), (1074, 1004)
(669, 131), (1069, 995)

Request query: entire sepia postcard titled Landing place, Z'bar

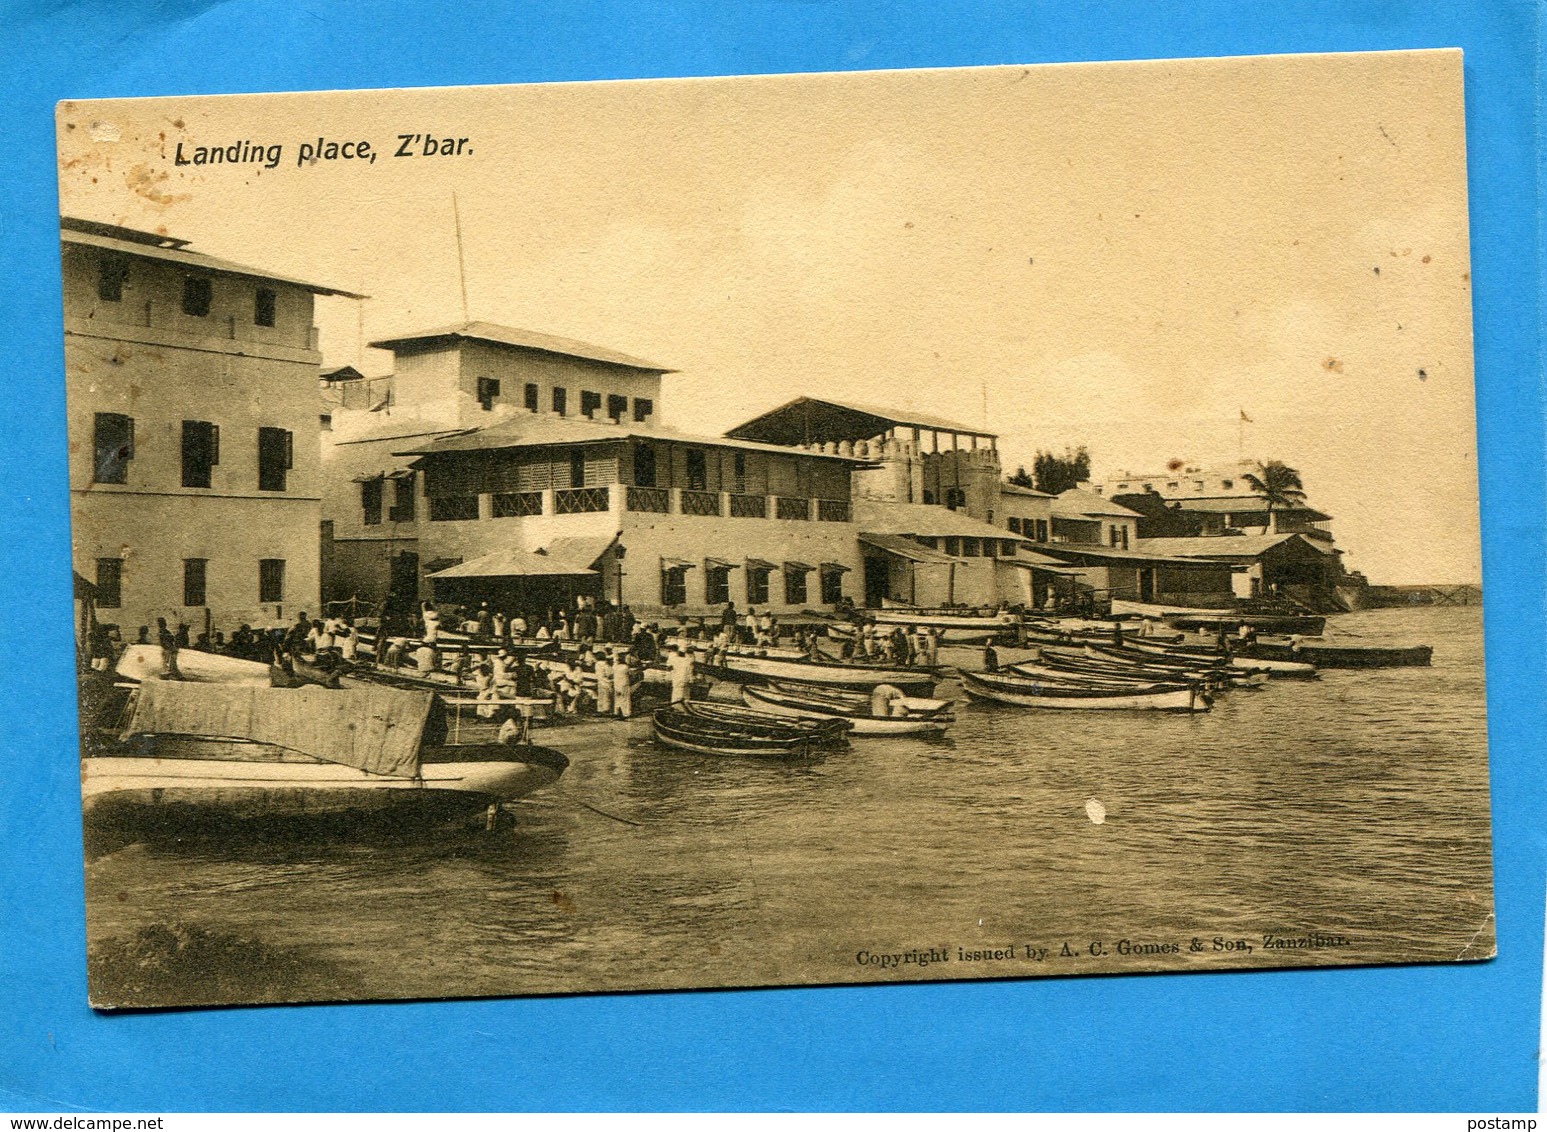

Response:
(59, 51), (1494, 1007)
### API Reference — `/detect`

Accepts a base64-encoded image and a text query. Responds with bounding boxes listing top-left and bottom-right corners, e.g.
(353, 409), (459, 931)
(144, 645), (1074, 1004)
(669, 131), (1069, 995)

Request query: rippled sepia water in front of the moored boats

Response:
(87, 608), (1493, 1002)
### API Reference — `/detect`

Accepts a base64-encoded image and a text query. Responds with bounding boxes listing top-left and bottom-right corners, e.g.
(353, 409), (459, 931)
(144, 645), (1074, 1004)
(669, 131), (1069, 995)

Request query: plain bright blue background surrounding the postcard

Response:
(0, 0), (1547, 1110)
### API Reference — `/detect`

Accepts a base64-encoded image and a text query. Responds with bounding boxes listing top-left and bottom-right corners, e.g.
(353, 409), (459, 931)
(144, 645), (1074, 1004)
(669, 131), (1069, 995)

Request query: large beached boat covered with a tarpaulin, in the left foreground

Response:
(82, 680), (568, 821)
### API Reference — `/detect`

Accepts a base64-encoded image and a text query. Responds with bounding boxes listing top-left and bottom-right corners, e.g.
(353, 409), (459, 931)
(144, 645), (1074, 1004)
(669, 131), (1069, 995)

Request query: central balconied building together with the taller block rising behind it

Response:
(325, 323), (871, 617)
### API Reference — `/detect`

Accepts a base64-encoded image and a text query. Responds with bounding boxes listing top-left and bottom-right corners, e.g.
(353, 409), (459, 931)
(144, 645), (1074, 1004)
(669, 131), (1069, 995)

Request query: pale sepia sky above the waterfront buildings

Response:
(59, 51), (1480, 585)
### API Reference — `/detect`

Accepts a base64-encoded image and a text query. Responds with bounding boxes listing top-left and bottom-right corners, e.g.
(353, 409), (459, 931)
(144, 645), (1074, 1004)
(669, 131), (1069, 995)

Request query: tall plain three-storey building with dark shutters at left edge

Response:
(60, 217), (360, 640)
